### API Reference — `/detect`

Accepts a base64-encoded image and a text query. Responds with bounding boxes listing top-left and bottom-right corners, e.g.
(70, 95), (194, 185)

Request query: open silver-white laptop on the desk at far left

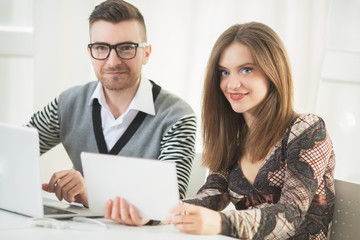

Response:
(0, 122), (101, 218)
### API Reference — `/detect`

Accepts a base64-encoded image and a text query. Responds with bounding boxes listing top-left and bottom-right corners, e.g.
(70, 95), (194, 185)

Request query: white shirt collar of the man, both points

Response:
(89, 75), (155, 115)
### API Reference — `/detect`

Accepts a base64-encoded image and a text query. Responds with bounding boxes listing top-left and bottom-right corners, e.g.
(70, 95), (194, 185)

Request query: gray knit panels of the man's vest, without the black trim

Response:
(58, 81), (194, 173)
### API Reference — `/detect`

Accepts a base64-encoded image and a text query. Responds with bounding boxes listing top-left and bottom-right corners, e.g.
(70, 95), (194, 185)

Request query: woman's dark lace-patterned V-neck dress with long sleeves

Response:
(185, 114), (335, 239)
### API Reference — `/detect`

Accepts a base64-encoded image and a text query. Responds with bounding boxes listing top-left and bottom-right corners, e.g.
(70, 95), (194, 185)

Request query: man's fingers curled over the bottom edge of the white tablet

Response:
(105, 197), (149, 226)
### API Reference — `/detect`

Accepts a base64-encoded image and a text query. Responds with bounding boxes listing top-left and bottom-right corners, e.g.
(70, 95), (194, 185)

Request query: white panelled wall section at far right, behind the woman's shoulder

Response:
(317, 0), (360, 183)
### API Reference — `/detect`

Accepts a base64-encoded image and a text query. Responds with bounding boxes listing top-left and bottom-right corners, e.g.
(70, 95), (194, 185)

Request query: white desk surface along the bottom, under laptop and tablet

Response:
(0, 210), (234, 240)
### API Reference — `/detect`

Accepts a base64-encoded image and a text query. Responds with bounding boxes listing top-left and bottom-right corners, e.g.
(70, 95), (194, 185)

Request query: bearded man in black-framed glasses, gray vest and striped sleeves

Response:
(28, 0), (196, 218)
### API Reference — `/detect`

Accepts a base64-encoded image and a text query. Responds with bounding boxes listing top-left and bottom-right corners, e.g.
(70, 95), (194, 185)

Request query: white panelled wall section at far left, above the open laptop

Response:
(0, 0), (34, 124)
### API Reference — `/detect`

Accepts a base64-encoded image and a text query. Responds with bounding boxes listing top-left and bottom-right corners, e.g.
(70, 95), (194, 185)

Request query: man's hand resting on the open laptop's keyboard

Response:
(42, 169), (89, 206)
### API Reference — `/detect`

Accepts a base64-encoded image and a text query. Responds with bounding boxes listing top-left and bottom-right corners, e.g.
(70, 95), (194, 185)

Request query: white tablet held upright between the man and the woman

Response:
(81, 152), (179, 221)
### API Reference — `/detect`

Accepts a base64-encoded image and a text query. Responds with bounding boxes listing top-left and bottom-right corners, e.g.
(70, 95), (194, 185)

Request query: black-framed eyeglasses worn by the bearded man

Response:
(88, 42), (146, 60)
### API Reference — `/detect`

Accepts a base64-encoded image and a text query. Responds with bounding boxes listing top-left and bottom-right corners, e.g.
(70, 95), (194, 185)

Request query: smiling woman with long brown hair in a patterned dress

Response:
(167, 22), (335, 239)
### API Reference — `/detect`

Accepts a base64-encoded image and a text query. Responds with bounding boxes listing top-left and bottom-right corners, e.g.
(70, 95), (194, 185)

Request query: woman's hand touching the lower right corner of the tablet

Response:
(166, 203), (221, 235)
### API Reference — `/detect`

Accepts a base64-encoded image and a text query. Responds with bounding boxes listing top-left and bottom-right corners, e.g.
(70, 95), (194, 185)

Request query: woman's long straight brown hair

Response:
(202, 22), (294, 171)
